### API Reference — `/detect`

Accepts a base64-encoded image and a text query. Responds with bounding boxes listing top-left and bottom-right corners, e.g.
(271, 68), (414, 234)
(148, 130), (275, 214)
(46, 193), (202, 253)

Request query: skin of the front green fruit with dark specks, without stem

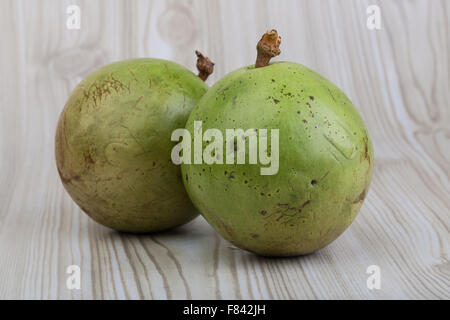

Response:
(182, 62), (373, 256)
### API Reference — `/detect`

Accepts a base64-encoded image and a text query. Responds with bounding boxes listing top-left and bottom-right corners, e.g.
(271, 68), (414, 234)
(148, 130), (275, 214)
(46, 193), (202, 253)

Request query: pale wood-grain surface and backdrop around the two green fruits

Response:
(0, 0), (450, 299)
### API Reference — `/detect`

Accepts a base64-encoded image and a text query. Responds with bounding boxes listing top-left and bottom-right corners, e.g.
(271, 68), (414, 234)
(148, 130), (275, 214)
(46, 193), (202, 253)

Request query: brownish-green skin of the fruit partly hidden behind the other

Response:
(55, 58), (208, 232)
